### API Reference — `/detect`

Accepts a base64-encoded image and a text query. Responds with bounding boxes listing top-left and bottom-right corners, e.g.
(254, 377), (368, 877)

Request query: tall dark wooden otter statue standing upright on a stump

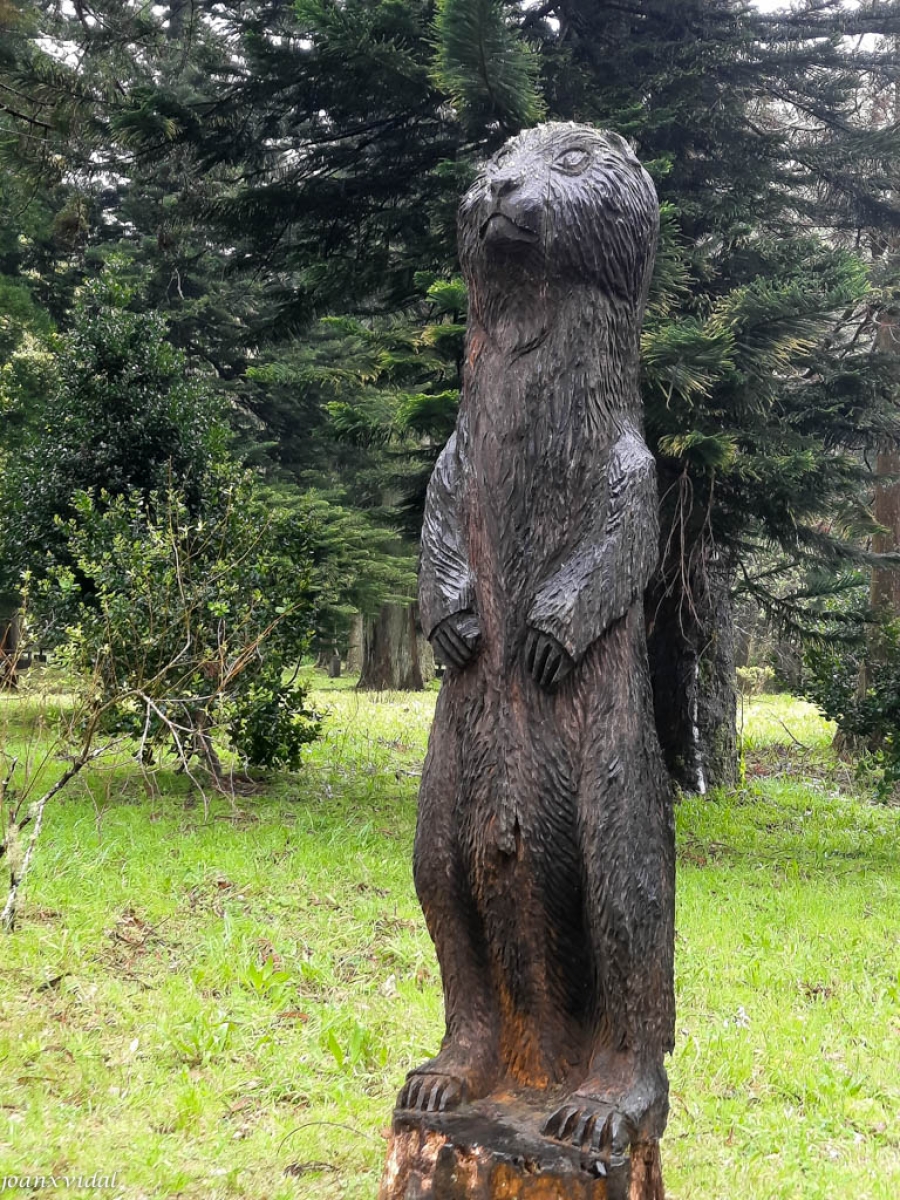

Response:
(398, 124), (674, 1153)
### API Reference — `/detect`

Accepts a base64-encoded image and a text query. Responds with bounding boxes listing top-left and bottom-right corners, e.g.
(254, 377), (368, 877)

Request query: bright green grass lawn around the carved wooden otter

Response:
(0, 688), (900, 1200)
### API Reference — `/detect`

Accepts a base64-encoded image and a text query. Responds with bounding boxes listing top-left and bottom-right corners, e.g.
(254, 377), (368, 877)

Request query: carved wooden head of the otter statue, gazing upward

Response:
(460, 124), (659, 320)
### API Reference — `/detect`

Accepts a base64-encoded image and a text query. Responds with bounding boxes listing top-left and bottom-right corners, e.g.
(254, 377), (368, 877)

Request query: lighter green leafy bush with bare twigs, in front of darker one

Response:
(38, 464), (318, 776)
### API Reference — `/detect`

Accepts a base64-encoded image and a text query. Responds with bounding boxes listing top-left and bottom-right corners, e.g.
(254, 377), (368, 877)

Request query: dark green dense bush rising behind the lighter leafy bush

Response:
(0, 262), (227, 597)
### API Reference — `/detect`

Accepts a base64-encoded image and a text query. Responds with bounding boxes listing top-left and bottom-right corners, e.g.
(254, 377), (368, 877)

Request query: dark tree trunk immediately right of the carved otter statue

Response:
(646, 540), (738, 796)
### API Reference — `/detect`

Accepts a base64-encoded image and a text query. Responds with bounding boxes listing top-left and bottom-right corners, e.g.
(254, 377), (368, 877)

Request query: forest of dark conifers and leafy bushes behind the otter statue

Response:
(0, 0), (900, 791)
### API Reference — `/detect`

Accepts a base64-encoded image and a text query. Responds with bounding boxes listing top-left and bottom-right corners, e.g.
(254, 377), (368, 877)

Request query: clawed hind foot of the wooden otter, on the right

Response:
(541, 1068), (668, 1156)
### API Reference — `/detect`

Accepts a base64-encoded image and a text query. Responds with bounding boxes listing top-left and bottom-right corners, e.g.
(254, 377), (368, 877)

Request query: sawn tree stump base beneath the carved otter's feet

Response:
(378, 1093), (664, 1200)
